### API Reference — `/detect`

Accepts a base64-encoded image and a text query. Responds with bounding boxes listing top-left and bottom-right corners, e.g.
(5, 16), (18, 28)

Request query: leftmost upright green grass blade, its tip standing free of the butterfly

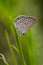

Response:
(5, 31), (18, 65)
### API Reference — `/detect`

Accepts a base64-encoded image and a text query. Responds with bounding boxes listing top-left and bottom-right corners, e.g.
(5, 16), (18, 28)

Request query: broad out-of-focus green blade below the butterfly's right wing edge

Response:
(26, 30), (37, 65)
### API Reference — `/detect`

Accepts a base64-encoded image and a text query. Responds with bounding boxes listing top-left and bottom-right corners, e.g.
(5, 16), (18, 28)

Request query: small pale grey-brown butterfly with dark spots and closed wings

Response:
(14, 15), (36, 35)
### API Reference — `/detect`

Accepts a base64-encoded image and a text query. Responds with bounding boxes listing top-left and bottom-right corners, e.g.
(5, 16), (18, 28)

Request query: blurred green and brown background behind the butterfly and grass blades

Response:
(0, 0), (43, 65)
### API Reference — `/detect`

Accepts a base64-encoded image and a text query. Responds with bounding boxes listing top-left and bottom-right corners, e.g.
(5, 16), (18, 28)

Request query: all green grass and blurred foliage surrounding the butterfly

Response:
(0, 0), (43, 65)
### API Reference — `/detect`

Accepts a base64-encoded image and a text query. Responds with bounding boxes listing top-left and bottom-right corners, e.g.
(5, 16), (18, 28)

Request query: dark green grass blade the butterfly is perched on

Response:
(11, 26), (26, 65)
